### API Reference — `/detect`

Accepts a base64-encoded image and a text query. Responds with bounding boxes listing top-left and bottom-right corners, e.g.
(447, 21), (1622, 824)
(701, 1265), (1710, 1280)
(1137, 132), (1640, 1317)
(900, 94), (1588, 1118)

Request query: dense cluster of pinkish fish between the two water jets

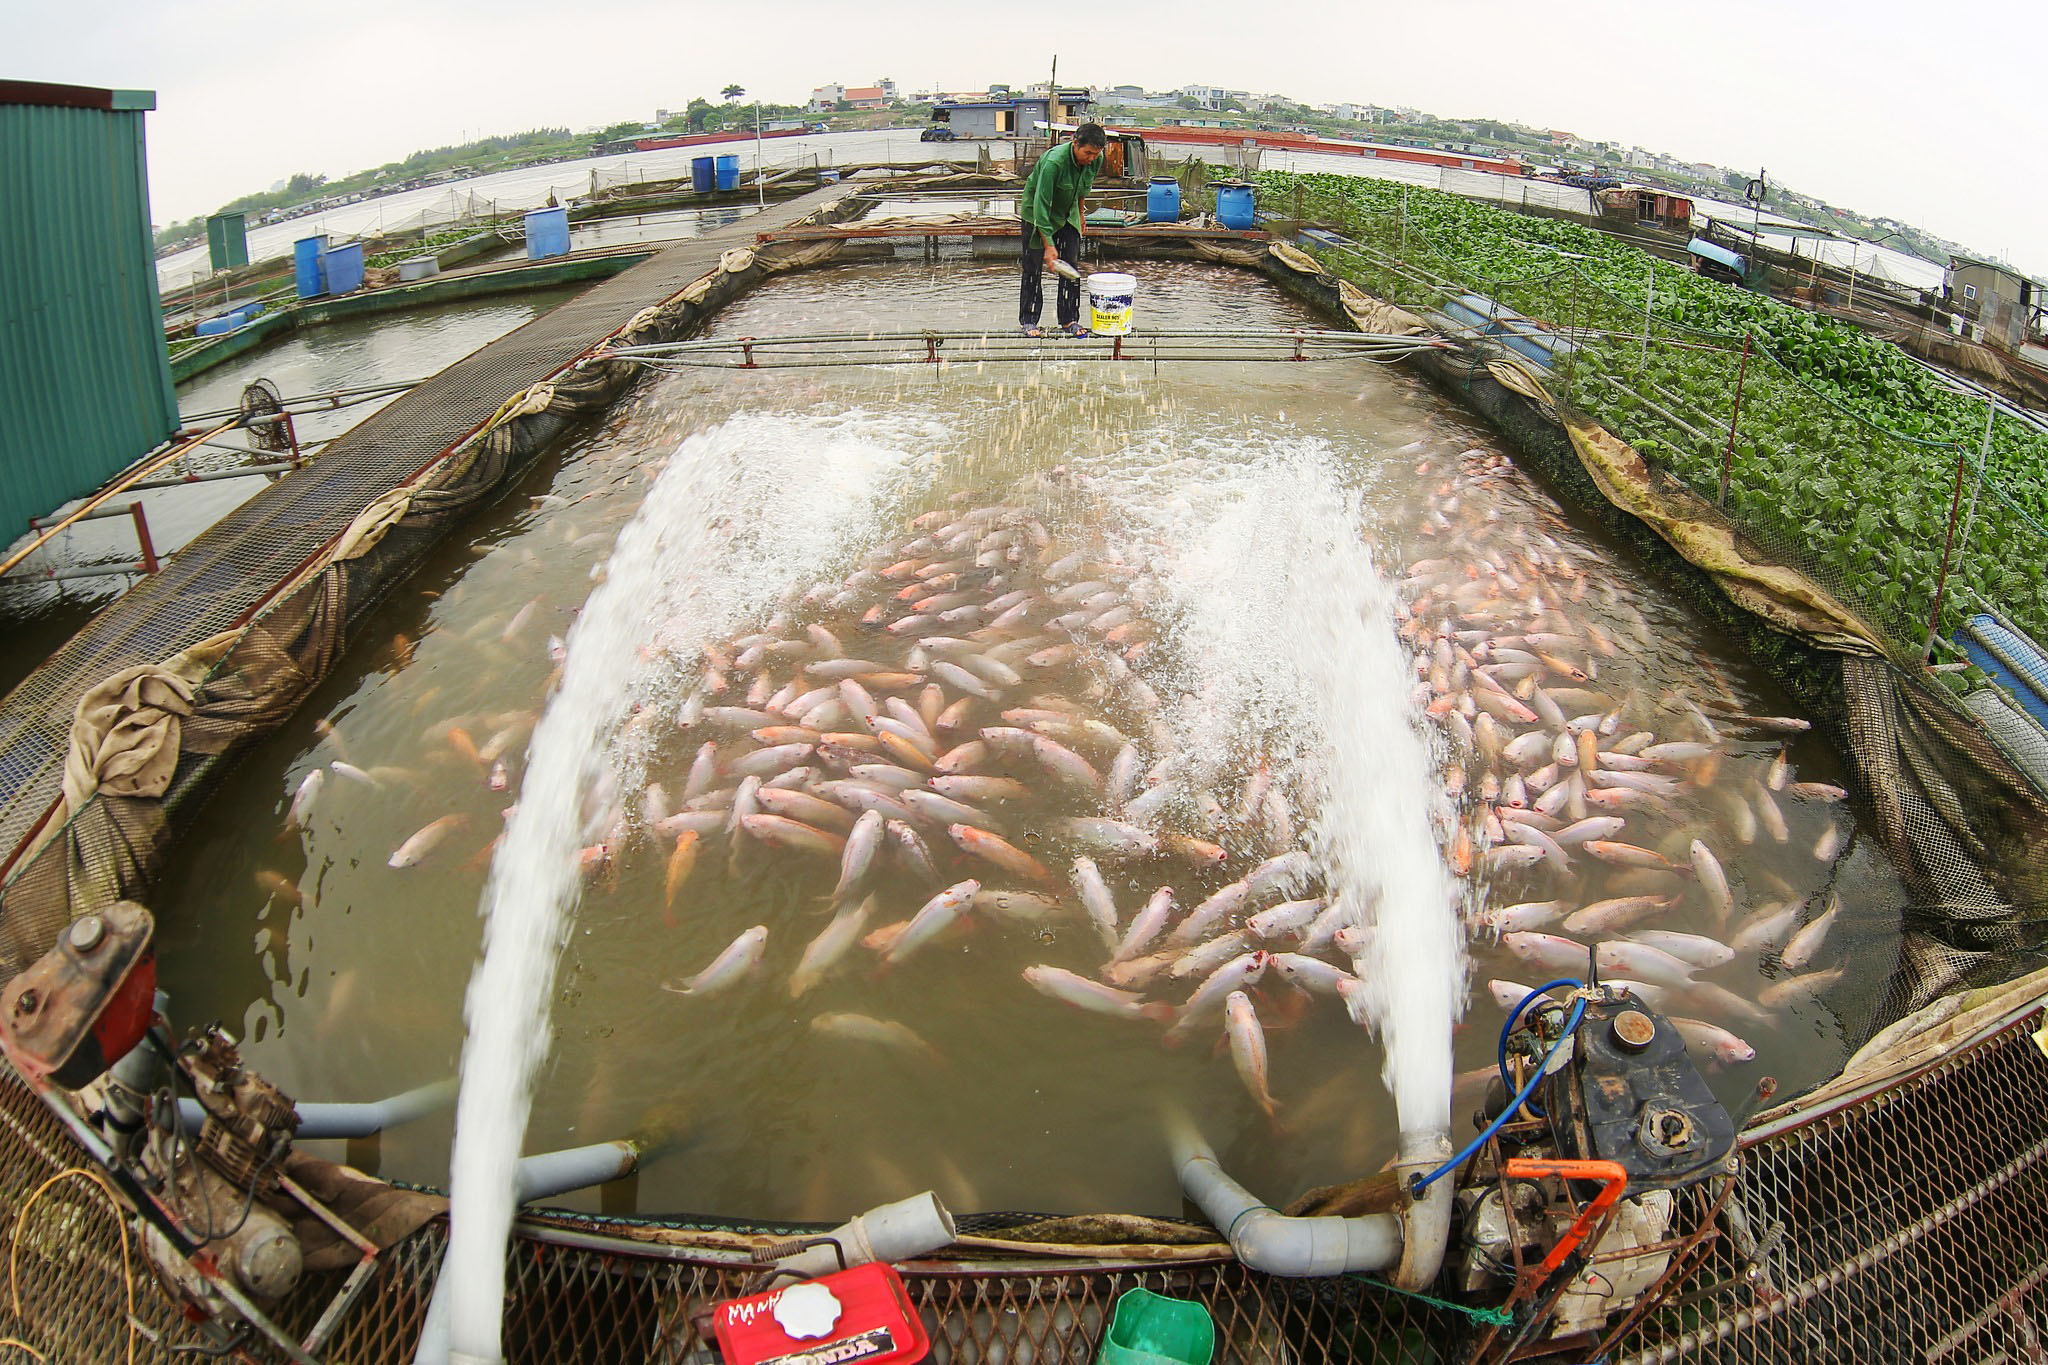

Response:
(618, 491), (1362, 1113)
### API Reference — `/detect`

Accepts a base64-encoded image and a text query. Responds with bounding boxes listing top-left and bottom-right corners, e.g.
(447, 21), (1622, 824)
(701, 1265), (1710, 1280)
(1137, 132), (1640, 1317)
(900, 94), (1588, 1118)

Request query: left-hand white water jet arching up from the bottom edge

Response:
(442, 411), (938, 1361)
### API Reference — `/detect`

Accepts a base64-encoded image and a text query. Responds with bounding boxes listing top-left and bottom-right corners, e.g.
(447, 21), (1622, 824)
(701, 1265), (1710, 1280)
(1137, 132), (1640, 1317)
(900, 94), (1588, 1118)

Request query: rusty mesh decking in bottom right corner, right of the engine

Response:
(1610, 1011), (2048, 1365)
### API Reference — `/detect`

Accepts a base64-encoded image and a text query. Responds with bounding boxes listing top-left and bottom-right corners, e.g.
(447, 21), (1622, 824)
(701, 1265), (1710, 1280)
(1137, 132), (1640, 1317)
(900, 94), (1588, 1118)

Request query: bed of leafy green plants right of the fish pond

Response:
(1260, 172), (2048, 657)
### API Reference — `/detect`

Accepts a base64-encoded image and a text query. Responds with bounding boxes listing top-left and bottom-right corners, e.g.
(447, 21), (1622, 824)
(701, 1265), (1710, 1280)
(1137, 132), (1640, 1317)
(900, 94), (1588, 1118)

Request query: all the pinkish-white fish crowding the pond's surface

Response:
(287, 448), (1853, 1117)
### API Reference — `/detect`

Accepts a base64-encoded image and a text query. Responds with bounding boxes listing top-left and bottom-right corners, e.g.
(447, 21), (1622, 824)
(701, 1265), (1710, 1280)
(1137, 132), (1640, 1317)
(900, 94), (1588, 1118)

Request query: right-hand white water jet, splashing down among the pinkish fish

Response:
(1128, 434), (1468, 1134)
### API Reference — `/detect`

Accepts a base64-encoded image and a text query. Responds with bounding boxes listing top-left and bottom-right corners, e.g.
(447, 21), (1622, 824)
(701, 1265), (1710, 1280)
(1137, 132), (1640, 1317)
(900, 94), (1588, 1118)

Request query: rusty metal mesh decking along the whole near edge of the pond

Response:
(0, 1011), (2048, 1365)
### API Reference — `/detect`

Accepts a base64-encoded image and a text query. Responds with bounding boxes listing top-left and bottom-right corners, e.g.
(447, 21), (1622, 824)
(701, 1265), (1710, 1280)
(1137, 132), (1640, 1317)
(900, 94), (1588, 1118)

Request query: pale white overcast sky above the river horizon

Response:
(19, 0), (2048, 274)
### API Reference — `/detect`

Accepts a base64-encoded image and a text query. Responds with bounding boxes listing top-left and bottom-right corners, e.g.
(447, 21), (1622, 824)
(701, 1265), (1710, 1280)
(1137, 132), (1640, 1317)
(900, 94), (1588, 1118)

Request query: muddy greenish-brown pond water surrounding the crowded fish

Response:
(160, 262), (1901, 1218)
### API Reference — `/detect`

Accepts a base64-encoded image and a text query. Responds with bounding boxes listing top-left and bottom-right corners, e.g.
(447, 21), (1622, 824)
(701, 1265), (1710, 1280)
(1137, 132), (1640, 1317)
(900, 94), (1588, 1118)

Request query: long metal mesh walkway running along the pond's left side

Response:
(0, 186), (844, 871)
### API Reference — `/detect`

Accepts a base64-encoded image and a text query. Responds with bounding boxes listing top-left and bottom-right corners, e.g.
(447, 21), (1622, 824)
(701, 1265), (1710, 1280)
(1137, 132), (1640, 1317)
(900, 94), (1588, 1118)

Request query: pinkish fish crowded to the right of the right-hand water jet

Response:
(1401, 450), (1853, 1064)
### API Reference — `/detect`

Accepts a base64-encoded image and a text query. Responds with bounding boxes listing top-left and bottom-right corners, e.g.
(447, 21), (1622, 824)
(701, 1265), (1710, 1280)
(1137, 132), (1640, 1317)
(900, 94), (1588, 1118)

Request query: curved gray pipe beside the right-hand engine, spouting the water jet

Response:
(1167, 1115), (1452, 1289)
